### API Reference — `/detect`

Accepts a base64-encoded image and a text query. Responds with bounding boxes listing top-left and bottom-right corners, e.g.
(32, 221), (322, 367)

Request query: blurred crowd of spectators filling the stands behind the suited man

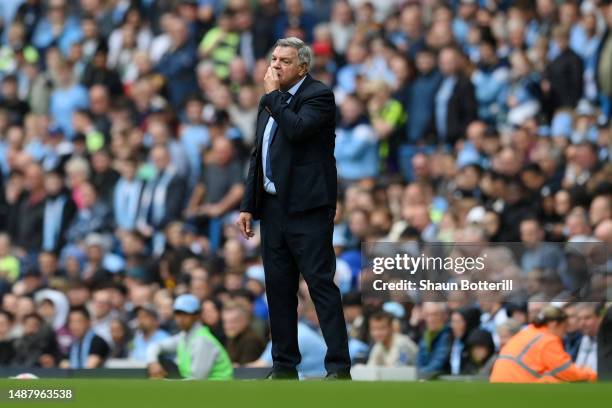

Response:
(0, 0), (612, 376)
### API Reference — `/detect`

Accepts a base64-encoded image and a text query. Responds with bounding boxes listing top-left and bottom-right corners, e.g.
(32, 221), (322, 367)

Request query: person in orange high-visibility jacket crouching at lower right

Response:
(489, 306), (597, 383)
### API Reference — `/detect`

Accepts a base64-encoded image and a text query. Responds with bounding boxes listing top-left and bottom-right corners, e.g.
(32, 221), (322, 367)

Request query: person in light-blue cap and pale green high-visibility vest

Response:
(147, 294), (233, 380)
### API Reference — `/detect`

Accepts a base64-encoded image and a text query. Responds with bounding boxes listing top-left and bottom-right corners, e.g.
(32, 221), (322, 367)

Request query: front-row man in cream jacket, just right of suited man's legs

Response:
(367, 311), (418, 367)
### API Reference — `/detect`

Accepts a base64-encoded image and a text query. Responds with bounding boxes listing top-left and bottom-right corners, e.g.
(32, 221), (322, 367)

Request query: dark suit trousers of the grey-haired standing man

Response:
(261, 193), (351, 372)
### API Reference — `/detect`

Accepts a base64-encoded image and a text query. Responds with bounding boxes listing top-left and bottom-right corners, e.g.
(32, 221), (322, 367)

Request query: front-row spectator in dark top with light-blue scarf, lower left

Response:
(60, 306), (110, 369)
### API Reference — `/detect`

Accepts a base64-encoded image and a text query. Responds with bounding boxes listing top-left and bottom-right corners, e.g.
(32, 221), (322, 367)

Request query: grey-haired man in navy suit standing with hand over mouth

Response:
(237, 37), (351, 379)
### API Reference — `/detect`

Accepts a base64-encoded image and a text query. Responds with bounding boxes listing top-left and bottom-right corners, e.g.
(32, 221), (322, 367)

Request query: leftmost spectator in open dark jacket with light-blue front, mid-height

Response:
(42, 171), (76, 252)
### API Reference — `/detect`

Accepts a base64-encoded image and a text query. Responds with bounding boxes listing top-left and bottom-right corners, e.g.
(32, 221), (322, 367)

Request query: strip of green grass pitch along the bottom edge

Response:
(0, 379), (612, 408)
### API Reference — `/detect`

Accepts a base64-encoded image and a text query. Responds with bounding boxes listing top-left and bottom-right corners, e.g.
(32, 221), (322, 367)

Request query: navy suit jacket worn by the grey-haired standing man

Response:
(240, 74), (338, 219)
